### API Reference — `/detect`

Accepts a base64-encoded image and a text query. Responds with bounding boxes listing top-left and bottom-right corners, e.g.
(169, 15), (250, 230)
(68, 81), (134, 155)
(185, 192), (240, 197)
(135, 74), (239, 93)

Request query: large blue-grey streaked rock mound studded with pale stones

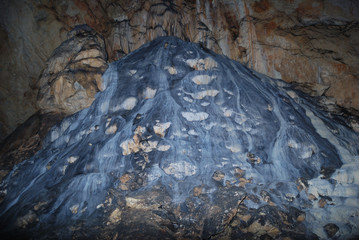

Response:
(0, 37), (359, 239)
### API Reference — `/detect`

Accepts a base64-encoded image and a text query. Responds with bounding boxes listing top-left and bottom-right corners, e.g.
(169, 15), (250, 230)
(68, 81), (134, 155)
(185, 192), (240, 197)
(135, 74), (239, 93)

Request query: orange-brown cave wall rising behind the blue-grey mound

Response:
(0, 0), (359, 139)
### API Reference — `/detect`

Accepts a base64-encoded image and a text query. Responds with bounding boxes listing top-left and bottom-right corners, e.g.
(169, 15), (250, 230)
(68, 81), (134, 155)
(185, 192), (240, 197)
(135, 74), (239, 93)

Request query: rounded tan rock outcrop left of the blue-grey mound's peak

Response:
(38, 25), (107, 115)
